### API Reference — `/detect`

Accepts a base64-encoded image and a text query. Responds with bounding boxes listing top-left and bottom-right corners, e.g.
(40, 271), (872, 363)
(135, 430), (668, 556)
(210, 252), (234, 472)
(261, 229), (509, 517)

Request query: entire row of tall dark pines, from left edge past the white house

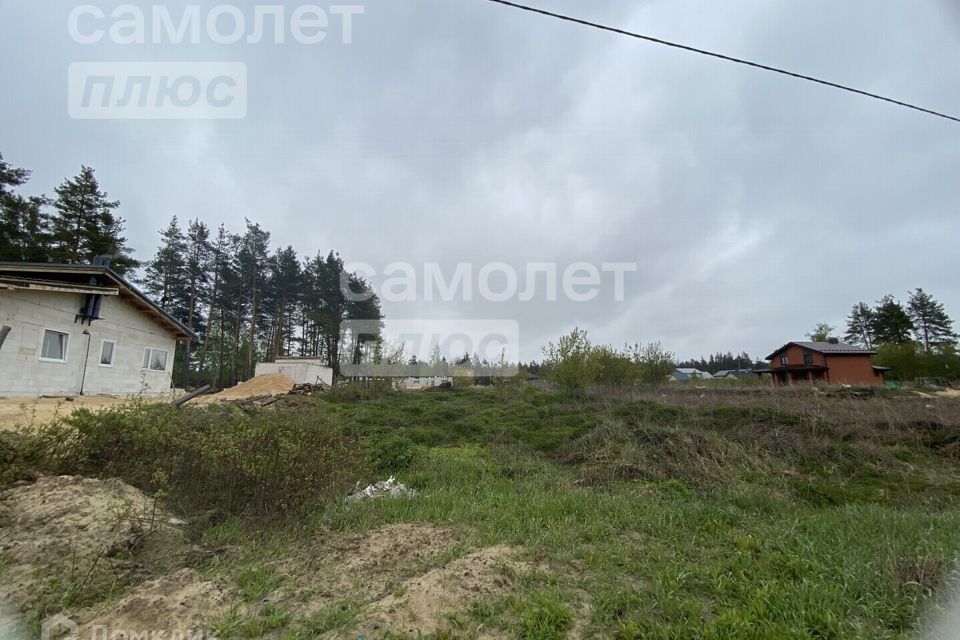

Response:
(0, 155), (383, 387)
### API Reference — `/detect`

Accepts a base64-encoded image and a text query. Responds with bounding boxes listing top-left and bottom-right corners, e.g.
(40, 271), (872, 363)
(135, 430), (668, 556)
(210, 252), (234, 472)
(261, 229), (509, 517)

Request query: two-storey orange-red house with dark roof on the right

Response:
(754, 338), (888, 386)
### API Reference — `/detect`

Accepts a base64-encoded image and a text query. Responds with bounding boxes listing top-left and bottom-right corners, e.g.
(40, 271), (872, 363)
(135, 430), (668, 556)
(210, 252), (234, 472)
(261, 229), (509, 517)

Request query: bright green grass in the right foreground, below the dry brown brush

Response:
(306, 448), (960, 638)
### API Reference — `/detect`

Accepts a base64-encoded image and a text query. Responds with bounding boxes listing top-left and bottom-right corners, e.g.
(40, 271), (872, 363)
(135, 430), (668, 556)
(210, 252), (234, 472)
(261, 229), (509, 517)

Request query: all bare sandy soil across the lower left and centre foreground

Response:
(0, 476), (529, 640)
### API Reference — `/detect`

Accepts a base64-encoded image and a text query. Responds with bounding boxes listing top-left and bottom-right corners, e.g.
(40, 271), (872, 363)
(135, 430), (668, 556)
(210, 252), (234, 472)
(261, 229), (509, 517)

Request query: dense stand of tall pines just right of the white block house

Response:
(140, 216), (383, 386)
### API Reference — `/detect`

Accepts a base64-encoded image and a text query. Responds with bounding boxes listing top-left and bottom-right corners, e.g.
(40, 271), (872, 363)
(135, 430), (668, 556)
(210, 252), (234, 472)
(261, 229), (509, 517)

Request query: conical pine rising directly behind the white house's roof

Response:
(52, 166), (138, 274)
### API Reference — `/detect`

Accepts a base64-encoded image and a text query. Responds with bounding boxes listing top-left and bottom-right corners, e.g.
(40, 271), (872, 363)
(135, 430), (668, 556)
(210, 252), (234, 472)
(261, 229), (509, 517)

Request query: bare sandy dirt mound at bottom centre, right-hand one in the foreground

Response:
(358, 546), (526, 638)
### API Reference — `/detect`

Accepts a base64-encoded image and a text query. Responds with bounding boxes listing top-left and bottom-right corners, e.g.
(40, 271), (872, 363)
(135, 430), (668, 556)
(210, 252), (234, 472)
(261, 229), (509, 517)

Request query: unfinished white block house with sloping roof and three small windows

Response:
(0, 262), (196, 397)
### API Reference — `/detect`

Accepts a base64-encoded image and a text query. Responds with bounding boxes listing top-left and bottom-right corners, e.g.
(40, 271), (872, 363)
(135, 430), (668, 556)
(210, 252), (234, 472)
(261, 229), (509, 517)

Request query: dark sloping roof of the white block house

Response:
(0, 261), (197, 340)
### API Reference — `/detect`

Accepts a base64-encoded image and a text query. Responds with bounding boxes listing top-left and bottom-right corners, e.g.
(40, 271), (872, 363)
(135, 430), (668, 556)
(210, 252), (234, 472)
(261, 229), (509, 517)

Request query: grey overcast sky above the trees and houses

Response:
(0, 0), (960, 359)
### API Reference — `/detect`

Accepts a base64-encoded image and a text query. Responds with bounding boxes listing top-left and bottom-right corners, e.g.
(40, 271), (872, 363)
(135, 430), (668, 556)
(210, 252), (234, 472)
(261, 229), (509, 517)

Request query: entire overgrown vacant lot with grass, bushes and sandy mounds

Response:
(0, 388), (960, 640)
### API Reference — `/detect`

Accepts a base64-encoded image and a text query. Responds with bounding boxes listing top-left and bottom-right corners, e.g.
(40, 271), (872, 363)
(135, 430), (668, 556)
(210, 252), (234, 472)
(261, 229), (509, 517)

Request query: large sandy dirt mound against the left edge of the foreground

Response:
(0, 476), (182, 608)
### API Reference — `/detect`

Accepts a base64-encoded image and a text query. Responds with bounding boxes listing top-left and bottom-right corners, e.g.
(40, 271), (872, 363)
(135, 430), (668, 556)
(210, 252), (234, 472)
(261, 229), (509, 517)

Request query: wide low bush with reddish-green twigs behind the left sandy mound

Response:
(54, 404), (365, 516)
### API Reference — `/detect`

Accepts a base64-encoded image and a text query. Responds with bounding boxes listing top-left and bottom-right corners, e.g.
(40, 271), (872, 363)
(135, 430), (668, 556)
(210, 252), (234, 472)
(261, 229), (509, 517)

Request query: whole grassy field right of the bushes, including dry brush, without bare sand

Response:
(9, 389), (960, 640)
